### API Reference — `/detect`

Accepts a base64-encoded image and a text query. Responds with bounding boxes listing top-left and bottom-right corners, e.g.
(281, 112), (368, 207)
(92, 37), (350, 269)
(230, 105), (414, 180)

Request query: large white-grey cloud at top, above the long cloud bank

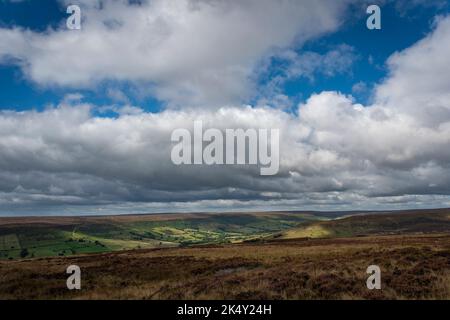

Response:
(0, 0), (349, 107)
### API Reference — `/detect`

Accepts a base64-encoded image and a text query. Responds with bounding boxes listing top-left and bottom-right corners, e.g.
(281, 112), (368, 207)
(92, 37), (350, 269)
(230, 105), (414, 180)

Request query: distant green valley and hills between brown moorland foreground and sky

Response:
(0, 210), (450, 260)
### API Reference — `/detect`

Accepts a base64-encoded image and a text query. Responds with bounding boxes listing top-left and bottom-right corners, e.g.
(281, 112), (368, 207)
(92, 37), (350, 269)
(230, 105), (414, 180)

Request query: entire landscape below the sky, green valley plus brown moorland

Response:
(0, 209), (450, 299)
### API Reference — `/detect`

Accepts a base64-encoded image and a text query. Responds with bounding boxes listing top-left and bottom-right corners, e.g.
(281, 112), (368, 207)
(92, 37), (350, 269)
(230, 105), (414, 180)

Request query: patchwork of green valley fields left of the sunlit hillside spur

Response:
(0, 213), (329, 260)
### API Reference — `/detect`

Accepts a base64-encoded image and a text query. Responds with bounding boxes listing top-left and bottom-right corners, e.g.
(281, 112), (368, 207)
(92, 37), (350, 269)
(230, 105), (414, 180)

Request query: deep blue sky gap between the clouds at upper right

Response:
(278, 3), (448, 103)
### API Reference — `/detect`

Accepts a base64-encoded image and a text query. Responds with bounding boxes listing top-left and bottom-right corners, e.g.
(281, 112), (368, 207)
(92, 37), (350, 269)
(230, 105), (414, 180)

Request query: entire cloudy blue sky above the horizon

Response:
(0, 0), (450, 216)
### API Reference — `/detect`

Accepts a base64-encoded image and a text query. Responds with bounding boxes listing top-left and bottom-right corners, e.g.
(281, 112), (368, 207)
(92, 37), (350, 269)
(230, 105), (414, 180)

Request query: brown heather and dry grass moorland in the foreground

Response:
(0, 235), (450, 299)
